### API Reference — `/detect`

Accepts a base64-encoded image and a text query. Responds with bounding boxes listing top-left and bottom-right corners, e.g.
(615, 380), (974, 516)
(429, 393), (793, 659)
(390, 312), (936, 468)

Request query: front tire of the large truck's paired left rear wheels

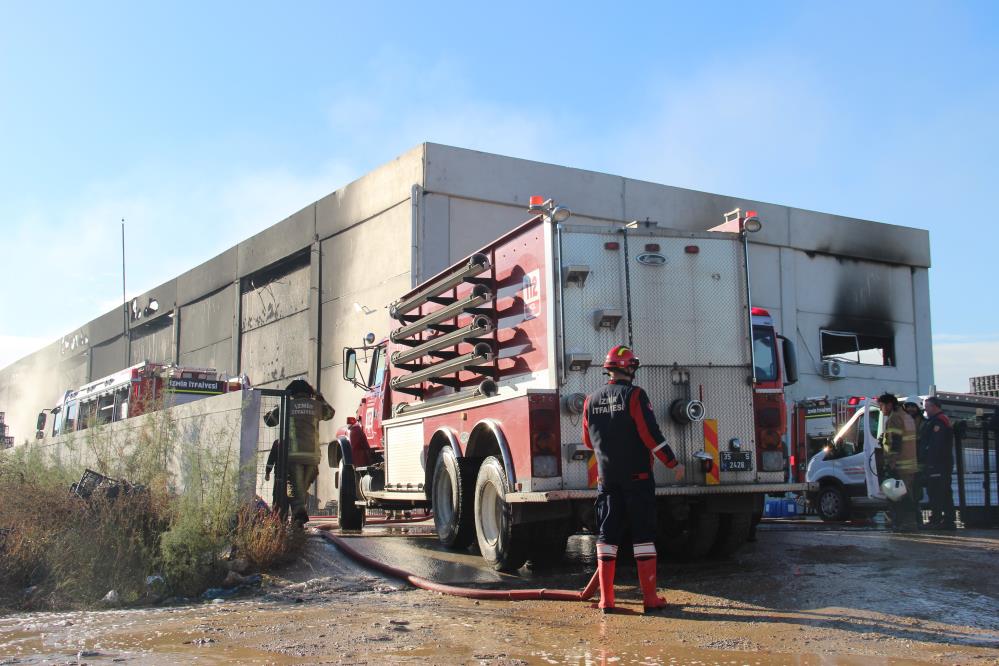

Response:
(431, 447), (475, 549)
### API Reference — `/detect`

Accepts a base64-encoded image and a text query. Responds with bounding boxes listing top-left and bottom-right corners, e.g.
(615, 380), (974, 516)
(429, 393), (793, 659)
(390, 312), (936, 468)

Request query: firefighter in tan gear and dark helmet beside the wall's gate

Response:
(272, 379), (334, 525)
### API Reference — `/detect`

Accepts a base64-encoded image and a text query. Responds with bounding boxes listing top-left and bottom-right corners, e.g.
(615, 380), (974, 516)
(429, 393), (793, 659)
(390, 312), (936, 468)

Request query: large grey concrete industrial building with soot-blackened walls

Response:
(0, 143), (933, 500)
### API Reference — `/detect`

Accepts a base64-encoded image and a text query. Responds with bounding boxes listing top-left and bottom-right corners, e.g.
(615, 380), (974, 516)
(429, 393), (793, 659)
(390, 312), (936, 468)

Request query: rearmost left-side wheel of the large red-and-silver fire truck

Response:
(475, 456), (529, 571)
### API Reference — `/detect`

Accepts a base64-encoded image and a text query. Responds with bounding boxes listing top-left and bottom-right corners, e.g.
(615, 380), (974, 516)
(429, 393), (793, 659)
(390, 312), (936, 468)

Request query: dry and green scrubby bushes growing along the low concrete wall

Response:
(0, 410), (304, 608)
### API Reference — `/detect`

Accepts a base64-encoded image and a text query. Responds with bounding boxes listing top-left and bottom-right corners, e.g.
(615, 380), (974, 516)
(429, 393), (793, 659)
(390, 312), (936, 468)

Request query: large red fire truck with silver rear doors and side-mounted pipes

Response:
(327, 197), (807, 570)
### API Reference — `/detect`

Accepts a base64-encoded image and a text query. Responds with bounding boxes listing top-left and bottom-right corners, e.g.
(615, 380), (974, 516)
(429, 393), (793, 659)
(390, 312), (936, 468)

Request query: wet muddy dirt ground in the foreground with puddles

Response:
(0, 523), (999, 666)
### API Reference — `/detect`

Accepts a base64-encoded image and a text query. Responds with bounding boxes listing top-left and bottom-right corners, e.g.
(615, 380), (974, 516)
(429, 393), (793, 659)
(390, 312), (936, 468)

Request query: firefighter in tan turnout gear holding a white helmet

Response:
(878, 393), (922, 532)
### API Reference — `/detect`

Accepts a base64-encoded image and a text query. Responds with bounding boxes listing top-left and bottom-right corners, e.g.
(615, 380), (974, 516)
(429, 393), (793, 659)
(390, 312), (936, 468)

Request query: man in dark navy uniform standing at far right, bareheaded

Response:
(919, 396), (955, 530)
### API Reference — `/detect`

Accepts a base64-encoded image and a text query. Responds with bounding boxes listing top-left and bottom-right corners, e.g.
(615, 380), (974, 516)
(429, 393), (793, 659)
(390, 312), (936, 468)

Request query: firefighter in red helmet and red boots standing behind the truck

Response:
(583, 345), (683, 613)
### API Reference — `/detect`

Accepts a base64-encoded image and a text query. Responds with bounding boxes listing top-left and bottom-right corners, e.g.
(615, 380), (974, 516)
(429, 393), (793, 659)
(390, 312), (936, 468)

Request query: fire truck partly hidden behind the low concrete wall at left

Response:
(35, 361), (234, 439)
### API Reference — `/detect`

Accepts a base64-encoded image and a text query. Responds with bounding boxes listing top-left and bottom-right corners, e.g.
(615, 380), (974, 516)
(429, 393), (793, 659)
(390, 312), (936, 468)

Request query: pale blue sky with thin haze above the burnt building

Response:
(0, 2), (999, 390)
